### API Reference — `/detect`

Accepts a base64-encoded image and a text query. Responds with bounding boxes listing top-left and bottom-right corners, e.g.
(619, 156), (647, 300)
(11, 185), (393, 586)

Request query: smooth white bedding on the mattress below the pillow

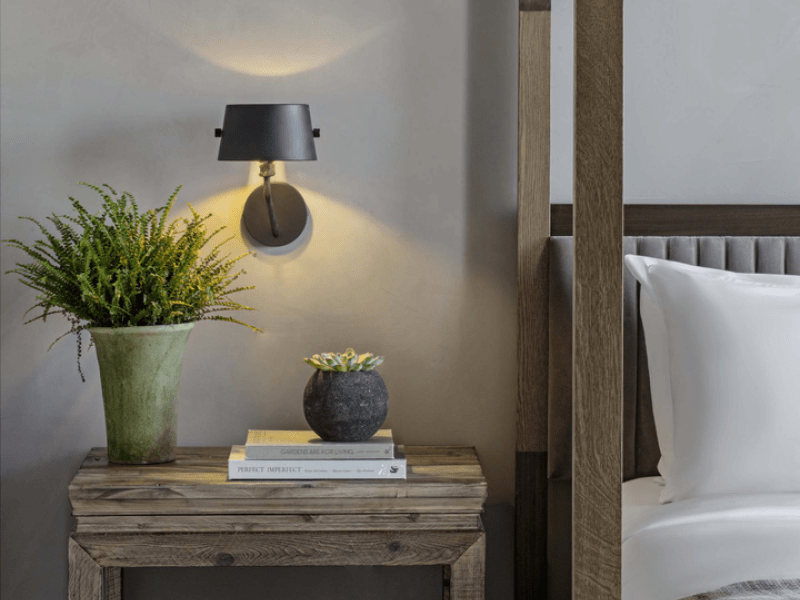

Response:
(622, 477), (800, 600)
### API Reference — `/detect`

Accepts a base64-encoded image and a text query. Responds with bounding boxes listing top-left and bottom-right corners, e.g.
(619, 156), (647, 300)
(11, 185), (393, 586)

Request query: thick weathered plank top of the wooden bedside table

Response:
(69, 447), (486, 517)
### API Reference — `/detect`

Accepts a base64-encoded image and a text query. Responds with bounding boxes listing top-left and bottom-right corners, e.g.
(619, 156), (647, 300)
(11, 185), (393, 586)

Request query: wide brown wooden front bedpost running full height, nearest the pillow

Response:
(572, 0), (623, 600)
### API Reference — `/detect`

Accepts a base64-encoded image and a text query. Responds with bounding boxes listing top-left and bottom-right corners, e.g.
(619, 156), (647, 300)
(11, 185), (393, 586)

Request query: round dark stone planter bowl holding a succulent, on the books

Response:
(303, 370), (389, 442)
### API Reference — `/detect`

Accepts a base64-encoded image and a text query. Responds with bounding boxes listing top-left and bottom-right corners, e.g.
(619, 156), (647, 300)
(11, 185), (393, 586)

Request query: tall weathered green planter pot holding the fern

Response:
(89, 323), (194, 465)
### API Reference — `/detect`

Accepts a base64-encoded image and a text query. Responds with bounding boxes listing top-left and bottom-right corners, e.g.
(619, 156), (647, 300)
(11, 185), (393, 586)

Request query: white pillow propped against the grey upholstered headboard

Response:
(625, 255), (800, 502)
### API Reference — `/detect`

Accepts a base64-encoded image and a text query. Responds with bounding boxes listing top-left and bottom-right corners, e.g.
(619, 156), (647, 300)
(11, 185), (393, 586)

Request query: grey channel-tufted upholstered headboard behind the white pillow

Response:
(548, 237), (800, 480)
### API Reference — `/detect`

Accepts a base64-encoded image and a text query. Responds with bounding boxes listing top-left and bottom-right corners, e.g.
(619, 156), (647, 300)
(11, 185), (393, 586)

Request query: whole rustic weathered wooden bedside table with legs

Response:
(69, 446), (486, 600)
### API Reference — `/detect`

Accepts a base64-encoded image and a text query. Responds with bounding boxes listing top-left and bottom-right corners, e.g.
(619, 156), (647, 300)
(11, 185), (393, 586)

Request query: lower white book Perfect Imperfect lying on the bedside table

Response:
(228, 446), (406, 479)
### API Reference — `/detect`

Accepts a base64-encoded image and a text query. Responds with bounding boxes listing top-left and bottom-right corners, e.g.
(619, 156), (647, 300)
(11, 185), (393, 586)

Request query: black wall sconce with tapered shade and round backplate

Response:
(215, 104), (319, 246)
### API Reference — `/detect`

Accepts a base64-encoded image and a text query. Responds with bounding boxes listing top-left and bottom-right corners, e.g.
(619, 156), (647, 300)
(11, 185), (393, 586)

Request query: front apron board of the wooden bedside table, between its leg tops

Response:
(76, 531), (483, 567)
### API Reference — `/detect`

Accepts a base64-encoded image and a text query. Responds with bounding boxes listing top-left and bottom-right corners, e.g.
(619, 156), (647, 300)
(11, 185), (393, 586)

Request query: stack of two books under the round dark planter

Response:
(228, 429), (406, 479)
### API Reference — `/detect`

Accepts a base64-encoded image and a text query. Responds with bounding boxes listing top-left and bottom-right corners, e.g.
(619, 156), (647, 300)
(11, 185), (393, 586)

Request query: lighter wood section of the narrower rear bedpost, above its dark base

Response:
(517, 12), (550, 452)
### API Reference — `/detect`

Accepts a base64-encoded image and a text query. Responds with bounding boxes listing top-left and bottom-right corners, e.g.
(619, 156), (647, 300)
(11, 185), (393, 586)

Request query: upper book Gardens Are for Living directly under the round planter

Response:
(245, 429), (394, 460)
